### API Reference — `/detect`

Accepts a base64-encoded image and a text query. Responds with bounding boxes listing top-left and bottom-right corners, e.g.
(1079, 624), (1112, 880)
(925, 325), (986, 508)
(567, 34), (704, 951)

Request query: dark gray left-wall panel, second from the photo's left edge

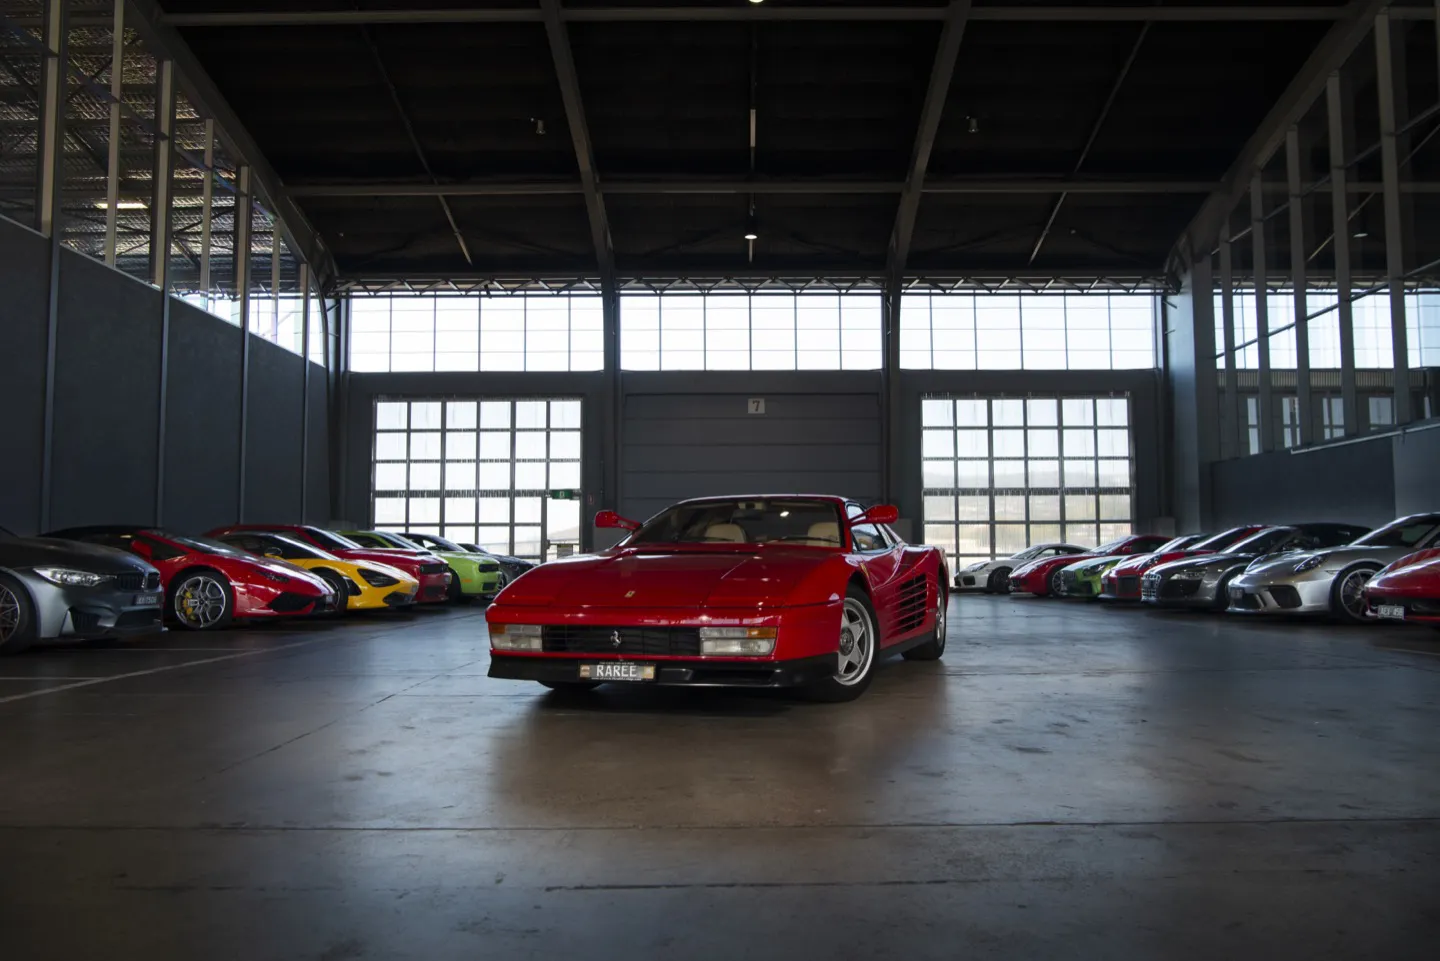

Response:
(50, 251), (160, 527)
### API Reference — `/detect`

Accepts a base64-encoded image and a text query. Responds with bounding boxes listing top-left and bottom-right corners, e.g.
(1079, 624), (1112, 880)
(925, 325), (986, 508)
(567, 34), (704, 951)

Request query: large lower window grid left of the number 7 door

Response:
(372, 398), (582, 559)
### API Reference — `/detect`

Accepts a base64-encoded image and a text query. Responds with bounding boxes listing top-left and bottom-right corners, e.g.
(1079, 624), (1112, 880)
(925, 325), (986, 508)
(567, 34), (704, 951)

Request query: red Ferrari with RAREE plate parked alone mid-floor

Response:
(485, 494), (949, 702)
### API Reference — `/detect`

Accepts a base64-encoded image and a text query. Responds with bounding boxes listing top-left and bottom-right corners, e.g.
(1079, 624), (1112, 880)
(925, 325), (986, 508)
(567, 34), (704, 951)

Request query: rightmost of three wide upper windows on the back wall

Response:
(900, 294), (1158, 370)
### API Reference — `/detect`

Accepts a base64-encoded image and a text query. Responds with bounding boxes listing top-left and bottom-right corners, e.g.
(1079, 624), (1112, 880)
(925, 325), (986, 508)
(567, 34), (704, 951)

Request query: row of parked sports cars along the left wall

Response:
(0, 524), (536, 653)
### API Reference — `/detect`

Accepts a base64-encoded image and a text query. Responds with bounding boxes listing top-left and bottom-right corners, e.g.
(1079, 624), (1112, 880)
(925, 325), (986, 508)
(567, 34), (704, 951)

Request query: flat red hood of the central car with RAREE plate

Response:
(495, 547), (837, 608)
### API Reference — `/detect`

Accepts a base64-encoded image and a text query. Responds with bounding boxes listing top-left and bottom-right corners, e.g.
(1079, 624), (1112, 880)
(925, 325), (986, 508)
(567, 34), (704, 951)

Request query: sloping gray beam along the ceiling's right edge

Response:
(1166, 0), (1387, 275)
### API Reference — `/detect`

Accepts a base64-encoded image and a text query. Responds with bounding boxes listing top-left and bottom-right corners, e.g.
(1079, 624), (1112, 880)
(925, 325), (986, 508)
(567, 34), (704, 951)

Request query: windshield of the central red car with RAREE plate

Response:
(625, 500), (842, 547)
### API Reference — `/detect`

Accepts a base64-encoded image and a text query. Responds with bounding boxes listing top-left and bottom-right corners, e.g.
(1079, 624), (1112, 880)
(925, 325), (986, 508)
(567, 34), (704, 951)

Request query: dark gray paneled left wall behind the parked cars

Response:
(0, 219), (331, 535)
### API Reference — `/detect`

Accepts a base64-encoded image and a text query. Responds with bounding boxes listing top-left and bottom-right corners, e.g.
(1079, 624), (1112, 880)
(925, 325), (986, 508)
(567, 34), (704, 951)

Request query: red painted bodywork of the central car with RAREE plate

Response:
(485, 494), (949, 683)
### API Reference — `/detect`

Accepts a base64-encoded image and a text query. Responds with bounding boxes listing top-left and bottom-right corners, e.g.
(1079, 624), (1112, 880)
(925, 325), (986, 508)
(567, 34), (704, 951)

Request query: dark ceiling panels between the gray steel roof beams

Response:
(143, 0), (1436, 277)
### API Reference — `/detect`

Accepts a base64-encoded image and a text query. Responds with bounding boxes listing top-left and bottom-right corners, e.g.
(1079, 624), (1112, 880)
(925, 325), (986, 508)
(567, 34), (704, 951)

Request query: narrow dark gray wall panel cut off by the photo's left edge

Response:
(0, 218), (49, 533)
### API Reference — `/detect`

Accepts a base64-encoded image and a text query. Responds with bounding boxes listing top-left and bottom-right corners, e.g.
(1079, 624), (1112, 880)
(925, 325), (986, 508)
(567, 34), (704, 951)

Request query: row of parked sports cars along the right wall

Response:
(955, 513), (1440, 625)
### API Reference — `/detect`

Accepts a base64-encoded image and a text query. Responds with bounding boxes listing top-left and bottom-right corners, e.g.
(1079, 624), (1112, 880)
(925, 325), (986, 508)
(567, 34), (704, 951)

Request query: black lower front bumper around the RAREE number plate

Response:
(490, 651), (838, 687)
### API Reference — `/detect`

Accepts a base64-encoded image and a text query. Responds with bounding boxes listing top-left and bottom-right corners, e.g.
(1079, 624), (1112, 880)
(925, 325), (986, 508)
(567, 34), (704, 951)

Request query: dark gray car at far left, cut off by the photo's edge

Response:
(0, 527), (164, 654)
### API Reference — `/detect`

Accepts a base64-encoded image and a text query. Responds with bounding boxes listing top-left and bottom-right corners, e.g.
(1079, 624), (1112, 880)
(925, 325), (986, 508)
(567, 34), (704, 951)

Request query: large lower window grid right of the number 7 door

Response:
(922, 396), (1135, 565)
